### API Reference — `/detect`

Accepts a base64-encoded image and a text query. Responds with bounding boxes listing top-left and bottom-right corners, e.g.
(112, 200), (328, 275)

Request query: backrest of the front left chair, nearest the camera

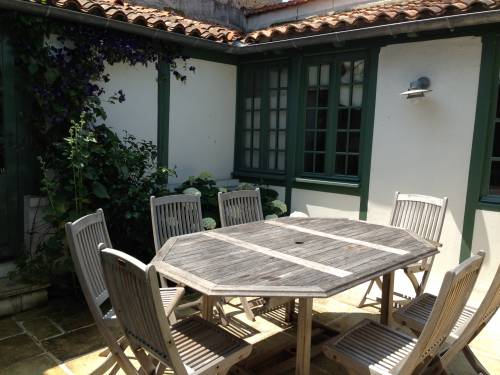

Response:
(101, 248), (187, 375)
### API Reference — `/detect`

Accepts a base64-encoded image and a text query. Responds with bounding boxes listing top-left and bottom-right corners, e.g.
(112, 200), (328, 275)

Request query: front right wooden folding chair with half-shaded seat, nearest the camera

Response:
(323, 254), (484, 375)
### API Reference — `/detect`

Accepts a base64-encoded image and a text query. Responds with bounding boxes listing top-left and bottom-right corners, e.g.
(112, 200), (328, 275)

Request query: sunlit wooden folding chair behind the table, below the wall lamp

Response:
(358, 191), (448, 307)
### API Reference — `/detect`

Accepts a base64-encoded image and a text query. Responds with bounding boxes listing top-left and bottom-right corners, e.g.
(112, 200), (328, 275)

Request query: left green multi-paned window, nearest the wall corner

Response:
(235, 62), (289, 176)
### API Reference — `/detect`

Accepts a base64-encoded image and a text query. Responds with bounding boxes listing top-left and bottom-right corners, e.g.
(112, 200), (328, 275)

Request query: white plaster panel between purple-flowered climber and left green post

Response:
(103, 63), (158, 144)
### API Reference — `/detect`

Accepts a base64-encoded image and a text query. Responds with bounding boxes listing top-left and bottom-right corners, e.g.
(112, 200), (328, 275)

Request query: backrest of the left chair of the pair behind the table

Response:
(150, 194), (203, 251)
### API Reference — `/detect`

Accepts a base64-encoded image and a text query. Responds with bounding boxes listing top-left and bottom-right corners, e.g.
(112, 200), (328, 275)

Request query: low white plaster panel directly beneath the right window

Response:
(291, 189), (359, 219)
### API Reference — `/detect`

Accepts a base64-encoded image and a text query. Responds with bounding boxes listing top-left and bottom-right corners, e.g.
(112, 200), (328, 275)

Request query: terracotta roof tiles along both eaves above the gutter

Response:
(20, 0), (500, 44)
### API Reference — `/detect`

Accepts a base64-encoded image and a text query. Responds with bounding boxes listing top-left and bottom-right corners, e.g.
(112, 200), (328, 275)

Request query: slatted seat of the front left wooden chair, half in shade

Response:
(172, 316), (252, 374)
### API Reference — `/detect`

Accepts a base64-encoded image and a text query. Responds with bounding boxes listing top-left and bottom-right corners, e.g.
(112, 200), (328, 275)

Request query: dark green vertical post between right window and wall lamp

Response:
(359, 47), (380, 220)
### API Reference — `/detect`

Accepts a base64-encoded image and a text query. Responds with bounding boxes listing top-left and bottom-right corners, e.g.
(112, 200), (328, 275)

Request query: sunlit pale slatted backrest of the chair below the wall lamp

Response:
(389, 191), (448, 242)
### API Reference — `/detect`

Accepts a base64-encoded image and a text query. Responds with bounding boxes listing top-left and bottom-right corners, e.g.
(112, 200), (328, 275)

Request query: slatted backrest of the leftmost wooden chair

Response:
(66, 209), (111, 320)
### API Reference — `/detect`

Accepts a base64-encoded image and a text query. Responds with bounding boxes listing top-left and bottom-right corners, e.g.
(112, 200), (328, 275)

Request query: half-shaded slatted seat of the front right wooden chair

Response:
(323, 319), (417, 375)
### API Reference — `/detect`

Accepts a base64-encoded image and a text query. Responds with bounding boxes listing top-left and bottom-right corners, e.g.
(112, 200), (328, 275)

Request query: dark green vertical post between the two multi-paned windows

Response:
(285, 53), (303, 210)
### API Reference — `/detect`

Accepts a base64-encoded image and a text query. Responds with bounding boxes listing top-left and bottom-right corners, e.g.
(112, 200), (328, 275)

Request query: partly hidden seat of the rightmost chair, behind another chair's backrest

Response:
(393, 293), (476, 338)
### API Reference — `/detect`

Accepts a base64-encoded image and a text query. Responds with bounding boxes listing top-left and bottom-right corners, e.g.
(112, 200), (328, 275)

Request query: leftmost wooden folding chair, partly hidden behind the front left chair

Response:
(66, 209), (180, 375)
